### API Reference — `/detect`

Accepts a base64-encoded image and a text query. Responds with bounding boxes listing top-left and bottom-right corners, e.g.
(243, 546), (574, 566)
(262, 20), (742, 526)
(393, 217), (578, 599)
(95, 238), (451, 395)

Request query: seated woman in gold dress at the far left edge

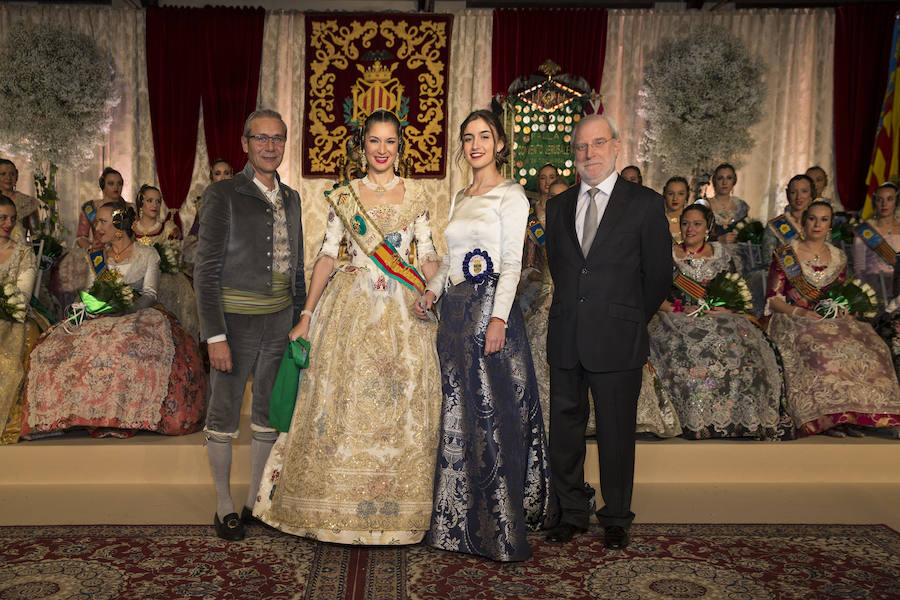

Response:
(0, 195), (37, 444)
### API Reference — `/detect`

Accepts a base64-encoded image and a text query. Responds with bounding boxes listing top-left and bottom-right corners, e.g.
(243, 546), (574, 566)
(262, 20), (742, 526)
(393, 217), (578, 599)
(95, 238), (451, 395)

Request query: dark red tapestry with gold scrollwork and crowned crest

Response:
(303, 13), (453, 178)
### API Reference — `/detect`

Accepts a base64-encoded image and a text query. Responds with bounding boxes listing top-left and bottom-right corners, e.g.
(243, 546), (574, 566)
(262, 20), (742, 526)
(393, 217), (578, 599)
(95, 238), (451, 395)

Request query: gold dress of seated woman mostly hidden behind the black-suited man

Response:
(519, 213), (681, 441)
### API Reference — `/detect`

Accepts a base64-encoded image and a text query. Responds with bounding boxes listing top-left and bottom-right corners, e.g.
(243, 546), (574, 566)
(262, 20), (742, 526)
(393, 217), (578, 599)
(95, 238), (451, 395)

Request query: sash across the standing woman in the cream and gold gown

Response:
(326, 184), (425, 294)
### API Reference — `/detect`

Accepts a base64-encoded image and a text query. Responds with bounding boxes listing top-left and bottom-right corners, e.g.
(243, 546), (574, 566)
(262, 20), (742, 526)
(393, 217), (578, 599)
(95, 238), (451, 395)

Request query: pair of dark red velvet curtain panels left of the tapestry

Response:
(147, 6), (266, 216)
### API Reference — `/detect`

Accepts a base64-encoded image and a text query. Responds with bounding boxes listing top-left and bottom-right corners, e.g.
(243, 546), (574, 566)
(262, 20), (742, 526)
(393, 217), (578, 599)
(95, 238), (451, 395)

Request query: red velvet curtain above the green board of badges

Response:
(492, 8), (606, 94)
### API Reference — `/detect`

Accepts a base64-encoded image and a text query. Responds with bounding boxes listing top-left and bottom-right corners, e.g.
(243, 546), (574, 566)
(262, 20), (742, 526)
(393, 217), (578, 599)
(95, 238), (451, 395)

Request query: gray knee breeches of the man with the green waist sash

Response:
(204, 306), (294, 437)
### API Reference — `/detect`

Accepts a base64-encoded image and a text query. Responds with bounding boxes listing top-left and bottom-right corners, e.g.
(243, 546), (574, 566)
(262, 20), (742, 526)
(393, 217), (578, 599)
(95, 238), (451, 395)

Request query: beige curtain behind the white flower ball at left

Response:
(0, 4), (156, 241)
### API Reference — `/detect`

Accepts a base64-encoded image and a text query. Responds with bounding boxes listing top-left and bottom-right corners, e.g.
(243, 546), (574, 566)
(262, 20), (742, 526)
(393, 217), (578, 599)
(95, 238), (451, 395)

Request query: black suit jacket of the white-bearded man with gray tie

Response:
(546, 177), (672, 372)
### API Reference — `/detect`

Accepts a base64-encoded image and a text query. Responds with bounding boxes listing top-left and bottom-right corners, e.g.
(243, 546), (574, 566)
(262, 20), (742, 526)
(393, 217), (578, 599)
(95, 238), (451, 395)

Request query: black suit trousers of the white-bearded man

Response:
(550, 363), (642, 528)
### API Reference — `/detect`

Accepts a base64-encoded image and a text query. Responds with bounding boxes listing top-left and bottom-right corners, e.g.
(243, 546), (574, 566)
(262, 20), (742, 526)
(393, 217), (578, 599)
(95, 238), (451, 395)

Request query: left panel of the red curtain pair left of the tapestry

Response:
(146, 7), (201, 210)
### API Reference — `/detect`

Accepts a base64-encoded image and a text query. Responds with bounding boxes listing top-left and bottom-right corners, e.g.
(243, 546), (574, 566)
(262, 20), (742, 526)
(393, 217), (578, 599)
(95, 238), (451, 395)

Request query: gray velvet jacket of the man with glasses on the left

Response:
(194, 162), (306, 340)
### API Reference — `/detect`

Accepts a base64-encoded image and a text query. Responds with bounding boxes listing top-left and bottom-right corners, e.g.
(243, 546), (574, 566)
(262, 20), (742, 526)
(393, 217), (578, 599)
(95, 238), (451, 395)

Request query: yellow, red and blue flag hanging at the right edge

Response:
(862, 17), (900, 218)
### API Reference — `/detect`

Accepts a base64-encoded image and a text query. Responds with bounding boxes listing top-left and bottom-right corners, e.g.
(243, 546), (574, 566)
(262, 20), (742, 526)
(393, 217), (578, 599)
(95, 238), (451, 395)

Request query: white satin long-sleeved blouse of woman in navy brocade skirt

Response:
(427, 180), (529, 321)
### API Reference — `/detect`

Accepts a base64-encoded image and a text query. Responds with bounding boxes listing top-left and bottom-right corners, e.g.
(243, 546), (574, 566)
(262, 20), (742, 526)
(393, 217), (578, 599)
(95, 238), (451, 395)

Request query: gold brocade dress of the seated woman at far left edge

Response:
(0, 244), (37, 444)
